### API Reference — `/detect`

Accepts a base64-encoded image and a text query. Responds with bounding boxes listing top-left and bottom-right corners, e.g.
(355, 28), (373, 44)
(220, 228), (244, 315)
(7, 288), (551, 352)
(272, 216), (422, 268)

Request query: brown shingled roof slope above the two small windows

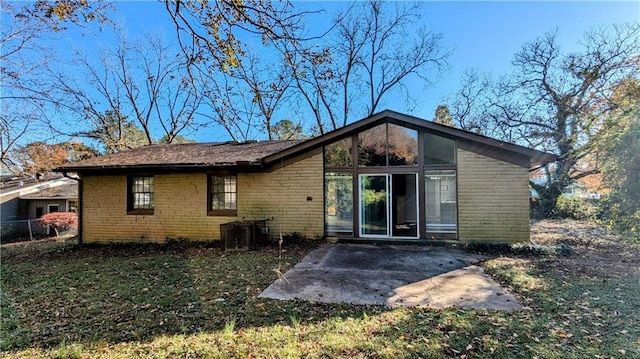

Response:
(56, 140), (301, 171)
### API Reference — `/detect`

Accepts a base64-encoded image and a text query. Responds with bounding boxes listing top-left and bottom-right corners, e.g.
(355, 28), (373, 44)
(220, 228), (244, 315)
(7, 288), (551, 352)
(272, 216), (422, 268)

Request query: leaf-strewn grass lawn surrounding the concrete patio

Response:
(0, 223), (640, 358)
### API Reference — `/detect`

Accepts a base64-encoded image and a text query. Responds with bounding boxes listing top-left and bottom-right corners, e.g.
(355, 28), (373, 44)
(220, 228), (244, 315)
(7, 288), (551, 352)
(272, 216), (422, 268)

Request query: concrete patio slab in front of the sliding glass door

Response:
(260, 244), (522, 311)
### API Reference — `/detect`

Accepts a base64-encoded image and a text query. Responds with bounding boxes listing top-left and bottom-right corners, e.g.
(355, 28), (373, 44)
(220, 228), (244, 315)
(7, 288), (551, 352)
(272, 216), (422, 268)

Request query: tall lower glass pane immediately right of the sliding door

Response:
(425, 171), (458, 233)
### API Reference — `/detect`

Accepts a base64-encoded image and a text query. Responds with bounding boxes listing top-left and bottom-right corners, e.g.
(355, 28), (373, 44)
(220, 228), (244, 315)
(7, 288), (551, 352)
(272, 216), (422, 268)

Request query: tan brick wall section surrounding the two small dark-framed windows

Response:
(82, 155), (323, 242)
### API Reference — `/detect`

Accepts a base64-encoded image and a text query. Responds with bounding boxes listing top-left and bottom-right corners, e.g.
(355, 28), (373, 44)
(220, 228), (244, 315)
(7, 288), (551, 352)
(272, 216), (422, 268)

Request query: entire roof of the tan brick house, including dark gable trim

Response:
(55, 110), (556, 172)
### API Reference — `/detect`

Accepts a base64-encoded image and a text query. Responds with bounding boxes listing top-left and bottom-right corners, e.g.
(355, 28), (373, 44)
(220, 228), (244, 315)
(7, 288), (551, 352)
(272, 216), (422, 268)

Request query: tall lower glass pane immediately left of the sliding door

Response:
(325, 172), (353, 233)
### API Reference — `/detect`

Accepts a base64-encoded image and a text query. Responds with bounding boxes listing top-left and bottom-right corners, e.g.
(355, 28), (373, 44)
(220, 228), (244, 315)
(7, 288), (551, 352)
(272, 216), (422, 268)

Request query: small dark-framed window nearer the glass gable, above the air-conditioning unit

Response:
(208, 175), (238, 216)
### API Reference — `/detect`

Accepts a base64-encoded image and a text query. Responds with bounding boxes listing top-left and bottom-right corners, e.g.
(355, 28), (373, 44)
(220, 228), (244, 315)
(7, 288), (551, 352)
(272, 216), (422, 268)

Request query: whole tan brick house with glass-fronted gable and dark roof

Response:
(57, 111), (556, 243)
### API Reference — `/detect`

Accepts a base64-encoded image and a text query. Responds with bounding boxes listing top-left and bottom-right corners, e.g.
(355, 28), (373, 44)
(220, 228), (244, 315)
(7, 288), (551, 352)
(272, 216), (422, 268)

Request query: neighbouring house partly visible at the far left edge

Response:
(0, 173), (78, 239)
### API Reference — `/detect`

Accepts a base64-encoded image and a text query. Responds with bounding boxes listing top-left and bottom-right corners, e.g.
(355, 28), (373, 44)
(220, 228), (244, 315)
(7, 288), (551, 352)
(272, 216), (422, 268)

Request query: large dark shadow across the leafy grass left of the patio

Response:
(0, 244), (386, 351)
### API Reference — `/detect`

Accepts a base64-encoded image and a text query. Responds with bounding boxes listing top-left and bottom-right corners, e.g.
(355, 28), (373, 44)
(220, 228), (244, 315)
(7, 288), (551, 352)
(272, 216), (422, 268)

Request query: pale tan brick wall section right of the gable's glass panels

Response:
(458, 150), (529, 242)
